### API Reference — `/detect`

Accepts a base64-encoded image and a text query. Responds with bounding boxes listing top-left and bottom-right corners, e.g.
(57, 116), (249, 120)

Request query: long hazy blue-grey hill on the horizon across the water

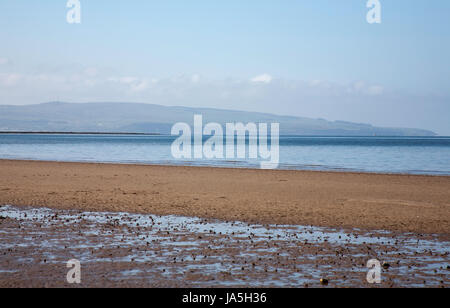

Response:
(0, 102), (436, 136)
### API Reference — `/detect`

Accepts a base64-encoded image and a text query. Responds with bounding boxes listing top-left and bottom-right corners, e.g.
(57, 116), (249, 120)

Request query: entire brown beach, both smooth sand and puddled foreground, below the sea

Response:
(0, 160), (450, 288)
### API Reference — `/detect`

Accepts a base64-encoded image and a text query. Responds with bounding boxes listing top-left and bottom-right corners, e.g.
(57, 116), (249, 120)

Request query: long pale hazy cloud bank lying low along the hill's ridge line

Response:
(0, 63), (450, 133)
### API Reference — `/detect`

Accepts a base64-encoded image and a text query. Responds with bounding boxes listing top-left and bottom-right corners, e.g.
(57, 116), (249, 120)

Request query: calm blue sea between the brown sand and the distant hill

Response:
(0, 134), (450, 175)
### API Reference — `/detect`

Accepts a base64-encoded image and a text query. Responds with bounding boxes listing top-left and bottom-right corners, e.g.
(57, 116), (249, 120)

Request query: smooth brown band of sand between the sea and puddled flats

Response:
(0, 160), (450, 235)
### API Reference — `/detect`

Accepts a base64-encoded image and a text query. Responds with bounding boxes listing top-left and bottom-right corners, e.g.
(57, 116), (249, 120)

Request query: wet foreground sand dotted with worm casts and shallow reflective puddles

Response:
(0, 206), (450, 287)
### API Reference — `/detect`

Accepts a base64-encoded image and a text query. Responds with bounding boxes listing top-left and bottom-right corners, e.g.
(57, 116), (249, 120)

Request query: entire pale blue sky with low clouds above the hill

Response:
(0, 0), (450, 135)
